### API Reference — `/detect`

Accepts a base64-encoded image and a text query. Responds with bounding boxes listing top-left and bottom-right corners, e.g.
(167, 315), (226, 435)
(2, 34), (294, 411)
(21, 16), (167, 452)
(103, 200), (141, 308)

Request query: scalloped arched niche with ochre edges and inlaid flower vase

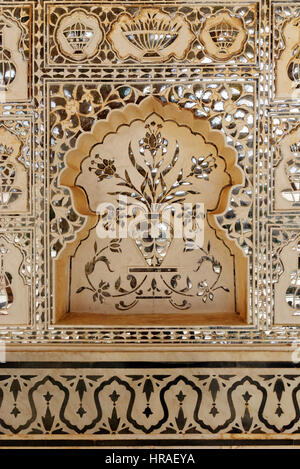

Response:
(54, 97), (248, 325)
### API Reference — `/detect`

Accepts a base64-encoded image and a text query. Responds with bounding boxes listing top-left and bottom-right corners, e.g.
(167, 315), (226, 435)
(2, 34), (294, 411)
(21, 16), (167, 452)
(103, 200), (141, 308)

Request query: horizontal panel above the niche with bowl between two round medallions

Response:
(45, 2), (257, 66)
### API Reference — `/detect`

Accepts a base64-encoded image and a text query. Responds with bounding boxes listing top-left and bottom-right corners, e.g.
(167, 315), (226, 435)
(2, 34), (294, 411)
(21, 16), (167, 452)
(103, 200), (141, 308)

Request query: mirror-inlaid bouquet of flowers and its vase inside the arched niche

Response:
(89, 122), (209, 265)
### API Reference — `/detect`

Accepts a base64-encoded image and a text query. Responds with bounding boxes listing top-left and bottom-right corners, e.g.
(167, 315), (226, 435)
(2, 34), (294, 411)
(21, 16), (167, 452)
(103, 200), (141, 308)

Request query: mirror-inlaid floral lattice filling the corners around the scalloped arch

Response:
(49, 83), (254, 256)
